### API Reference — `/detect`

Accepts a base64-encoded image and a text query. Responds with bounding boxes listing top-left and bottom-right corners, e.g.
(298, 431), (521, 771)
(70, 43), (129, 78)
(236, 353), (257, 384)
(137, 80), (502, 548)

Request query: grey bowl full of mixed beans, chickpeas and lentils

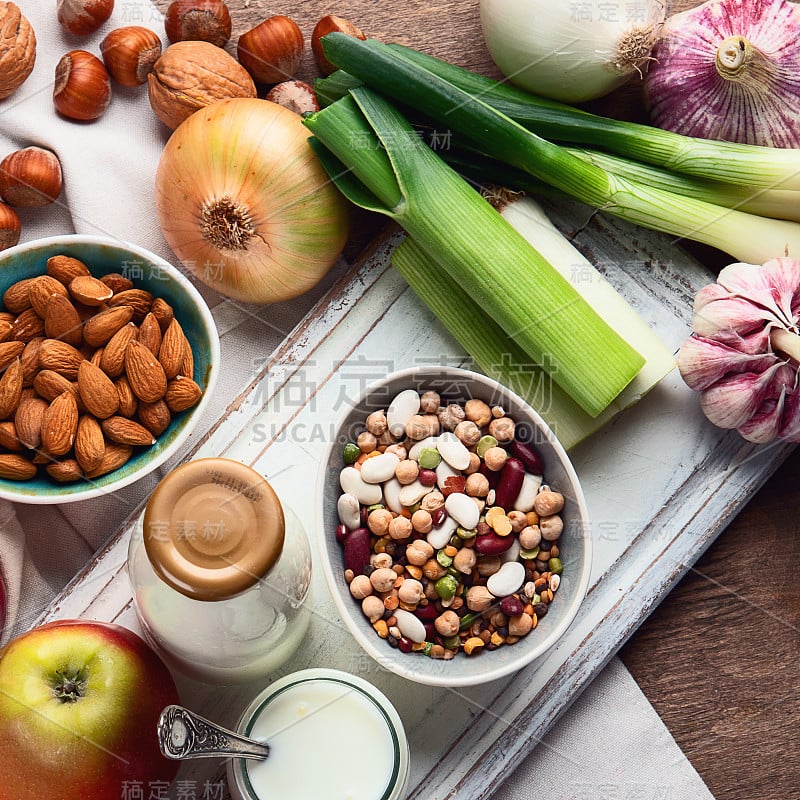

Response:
(317, 366), (592, 687)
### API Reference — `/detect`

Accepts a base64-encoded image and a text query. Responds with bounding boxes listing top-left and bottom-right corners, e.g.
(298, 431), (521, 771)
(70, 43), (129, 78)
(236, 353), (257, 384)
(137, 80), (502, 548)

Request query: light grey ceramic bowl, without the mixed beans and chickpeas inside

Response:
(317, 367), (592, 686)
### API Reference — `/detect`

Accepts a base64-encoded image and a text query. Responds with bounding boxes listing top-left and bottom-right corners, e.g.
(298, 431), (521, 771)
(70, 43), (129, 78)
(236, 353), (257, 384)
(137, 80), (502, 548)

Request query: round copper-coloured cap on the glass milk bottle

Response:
(144, 458), (285, 600)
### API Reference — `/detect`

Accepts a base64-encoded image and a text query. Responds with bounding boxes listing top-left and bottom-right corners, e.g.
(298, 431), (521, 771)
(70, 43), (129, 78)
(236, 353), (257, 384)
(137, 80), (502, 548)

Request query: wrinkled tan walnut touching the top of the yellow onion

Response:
(147, 41), (256, 130)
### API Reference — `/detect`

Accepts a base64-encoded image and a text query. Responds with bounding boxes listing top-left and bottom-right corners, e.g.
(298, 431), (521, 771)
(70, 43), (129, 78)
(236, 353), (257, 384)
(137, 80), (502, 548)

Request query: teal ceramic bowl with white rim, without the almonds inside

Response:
(0, 234), (220, 504)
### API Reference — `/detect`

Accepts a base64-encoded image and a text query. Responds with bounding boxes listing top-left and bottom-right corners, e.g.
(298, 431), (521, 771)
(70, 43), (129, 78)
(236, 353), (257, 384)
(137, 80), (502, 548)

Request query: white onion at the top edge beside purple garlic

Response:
(481, 0), (665, 103)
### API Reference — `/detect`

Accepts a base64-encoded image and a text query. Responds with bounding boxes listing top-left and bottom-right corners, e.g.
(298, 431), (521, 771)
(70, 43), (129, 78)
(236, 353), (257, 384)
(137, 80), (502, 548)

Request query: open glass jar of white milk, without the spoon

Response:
(228, 669), (409, 800)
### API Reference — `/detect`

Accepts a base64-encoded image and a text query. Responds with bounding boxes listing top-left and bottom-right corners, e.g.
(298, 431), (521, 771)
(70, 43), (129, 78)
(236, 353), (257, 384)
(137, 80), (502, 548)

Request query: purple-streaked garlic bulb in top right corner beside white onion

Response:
(645, 0), (800, 148)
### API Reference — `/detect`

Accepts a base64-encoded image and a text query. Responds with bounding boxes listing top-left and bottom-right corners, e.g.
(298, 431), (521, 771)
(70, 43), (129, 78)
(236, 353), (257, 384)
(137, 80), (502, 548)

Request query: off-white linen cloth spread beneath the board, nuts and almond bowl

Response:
(0, 0), (711, 800)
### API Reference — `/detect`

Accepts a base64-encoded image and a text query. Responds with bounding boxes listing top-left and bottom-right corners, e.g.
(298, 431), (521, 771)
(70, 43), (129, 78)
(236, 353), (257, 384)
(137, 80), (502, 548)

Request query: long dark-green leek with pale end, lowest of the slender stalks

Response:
(322, 33), (800, 264)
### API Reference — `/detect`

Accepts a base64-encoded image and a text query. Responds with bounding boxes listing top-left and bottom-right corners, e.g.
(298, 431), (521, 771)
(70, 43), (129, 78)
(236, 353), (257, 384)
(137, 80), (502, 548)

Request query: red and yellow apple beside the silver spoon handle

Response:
(0, 620), (178, 800)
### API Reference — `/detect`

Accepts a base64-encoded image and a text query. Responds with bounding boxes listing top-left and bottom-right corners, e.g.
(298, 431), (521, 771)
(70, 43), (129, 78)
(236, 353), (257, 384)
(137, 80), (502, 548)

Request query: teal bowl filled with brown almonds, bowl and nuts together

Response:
(0, 235), (219, 504)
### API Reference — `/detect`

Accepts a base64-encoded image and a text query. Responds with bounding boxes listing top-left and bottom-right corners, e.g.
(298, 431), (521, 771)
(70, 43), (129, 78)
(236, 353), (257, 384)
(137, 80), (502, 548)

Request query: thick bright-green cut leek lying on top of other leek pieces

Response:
(304, 88), (644, 417)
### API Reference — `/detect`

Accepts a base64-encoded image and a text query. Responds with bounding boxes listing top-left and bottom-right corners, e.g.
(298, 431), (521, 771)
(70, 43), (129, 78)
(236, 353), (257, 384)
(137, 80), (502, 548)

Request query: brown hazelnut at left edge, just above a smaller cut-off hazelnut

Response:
(0, 147), (61, 208)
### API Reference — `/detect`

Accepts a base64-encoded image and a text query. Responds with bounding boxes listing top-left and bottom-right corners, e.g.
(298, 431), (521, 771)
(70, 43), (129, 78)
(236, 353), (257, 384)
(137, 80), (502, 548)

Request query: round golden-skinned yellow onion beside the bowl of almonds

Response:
(156, 98), (347, 303)
